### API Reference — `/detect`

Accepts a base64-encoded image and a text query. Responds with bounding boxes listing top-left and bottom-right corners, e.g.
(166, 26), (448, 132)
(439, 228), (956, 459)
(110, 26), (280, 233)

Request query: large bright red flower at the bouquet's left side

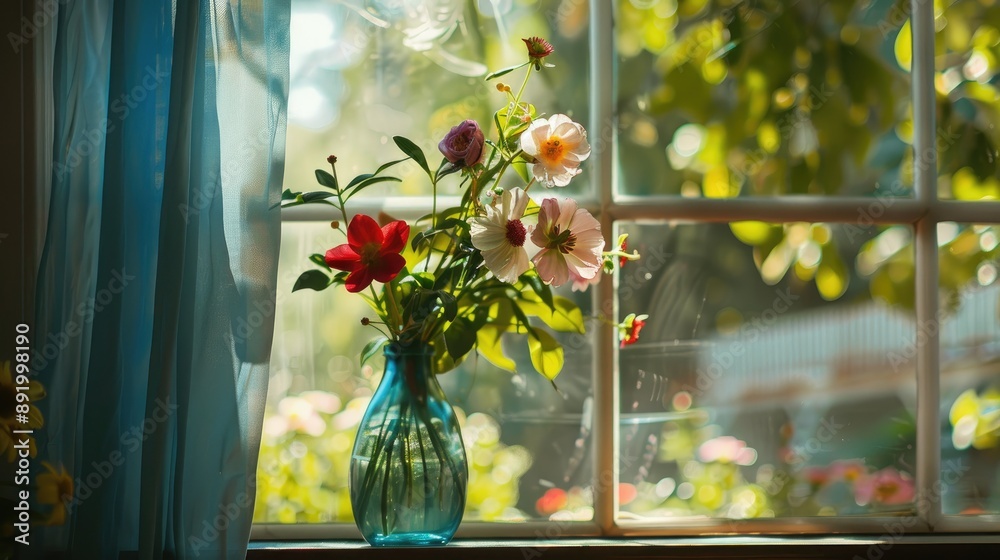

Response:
(326, 214), (410, 292)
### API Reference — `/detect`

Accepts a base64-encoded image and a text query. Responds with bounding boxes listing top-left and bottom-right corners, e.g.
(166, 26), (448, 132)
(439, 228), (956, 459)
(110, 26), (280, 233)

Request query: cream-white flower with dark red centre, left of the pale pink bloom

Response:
(469, 188), (531, 284)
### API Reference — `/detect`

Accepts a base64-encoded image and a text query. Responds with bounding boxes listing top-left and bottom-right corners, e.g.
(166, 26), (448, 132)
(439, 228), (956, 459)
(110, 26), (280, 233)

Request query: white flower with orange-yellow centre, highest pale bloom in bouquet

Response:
(521, 115), (590, 187)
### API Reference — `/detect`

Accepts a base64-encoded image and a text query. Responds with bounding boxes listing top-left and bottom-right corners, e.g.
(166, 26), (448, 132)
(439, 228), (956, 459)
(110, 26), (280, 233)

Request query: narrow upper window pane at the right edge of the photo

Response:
(934, 0), (1000, 200)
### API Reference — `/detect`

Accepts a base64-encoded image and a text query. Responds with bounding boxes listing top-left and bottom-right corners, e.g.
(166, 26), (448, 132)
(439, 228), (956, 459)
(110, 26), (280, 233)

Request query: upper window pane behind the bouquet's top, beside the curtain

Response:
(285, 0), (590, 197)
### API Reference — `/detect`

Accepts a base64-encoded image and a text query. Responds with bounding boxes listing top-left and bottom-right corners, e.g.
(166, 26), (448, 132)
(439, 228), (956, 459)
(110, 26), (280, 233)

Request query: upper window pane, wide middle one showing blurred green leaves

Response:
(616, 0), (913, 198)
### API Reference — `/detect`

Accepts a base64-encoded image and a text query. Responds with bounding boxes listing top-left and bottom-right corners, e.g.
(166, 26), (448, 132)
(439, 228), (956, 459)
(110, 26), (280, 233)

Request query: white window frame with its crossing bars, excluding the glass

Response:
(251, 0), (1000, 540)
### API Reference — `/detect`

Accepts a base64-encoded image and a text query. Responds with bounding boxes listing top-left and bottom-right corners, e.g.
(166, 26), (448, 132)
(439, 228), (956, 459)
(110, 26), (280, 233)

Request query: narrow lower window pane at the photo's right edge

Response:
(938, 223), (1000, 515)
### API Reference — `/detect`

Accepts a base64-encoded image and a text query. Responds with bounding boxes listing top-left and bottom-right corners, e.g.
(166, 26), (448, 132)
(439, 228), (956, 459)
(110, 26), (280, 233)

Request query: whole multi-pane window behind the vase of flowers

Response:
(254, 0), (1000, 538)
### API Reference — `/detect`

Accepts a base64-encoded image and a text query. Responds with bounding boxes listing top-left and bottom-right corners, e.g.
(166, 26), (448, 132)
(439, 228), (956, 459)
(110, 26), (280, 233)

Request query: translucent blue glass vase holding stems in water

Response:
(350, 343), (469, 546)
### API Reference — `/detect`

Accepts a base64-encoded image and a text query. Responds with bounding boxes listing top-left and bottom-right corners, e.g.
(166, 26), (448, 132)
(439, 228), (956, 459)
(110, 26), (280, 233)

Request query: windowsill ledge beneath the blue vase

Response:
(247, 534), (1000, 560)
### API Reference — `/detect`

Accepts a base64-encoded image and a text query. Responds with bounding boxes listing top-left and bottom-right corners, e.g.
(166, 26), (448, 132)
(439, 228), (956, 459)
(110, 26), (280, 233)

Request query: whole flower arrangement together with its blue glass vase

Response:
(282, 37), (645, 545)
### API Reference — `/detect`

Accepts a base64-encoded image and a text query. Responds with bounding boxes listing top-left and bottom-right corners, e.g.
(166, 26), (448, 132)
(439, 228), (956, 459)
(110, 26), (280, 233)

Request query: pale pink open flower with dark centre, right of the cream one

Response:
(531, 198), (604, 286)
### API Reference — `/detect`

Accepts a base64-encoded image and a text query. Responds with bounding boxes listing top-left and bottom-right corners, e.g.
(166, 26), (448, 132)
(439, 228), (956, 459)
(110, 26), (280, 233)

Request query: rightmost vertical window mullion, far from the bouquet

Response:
(910, 0), (941, 530)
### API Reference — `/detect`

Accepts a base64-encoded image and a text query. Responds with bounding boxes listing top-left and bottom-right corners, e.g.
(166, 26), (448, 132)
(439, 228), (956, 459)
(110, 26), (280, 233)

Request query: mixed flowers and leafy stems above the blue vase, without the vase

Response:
(281, 37), (645, 380)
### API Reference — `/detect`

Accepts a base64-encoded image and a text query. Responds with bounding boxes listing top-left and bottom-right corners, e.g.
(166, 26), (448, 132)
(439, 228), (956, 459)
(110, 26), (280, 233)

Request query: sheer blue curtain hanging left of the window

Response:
(30, 0), (289, 559)
